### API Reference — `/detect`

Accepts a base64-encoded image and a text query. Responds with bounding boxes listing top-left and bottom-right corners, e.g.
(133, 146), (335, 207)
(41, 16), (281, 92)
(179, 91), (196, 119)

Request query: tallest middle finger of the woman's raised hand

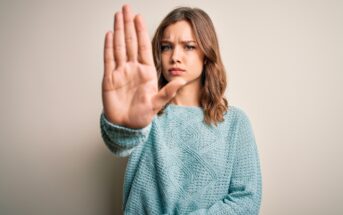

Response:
(123, 5), (137, 61)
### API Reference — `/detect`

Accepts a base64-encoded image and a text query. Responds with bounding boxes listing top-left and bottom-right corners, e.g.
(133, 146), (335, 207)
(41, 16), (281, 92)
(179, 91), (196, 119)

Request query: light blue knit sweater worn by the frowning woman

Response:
(100, 104), (262, 215)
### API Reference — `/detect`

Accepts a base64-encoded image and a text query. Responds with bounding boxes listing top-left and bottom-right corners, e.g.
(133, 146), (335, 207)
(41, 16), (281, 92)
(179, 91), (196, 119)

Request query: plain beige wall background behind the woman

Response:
(0, 0), (343, 215)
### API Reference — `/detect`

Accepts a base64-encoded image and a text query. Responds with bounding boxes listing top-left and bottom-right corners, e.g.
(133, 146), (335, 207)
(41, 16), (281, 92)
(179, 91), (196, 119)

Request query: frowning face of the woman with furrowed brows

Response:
(161, 21), (204, 83)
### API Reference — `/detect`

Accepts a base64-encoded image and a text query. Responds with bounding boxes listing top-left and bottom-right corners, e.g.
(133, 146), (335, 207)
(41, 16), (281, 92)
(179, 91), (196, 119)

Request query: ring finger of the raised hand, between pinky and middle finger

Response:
(113, 12), (126, 68)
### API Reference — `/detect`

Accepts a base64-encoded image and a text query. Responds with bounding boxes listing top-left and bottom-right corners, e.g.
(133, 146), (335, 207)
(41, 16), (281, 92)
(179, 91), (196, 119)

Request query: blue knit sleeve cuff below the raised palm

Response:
(100, 112), (151, 157)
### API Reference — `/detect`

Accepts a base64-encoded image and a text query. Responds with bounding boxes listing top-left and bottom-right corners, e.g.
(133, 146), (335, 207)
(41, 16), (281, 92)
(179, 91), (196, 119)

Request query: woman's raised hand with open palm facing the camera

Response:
(102, 5), (185, 128)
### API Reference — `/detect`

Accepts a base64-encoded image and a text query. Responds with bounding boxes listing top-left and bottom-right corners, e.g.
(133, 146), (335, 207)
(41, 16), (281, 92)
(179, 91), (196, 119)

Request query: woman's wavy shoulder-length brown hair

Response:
(152, 7), (228, 125)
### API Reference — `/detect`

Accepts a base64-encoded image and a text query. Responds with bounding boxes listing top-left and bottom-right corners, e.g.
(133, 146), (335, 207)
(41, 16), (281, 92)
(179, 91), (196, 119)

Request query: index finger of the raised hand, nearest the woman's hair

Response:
(134, 15), (154, 65)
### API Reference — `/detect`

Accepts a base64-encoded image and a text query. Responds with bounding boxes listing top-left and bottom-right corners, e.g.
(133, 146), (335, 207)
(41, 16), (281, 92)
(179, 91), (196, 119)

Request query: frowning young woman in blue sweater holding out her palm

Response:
(100, 5), (261, 215)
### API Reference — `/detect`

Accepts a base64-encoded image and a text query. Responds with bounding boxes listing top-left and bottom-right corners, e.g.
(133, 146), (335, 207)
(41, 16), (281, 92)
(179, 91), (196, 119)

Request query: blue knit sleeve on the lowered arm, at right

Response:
(190, 110), (262, 215)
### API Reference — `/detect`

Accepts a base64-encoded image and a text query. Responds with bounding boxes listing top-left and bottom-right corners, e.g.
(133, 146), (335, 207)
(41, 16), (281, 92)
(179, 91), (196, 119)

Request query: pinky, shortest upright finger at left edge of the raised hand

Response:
(104, 32), (114, 76)
